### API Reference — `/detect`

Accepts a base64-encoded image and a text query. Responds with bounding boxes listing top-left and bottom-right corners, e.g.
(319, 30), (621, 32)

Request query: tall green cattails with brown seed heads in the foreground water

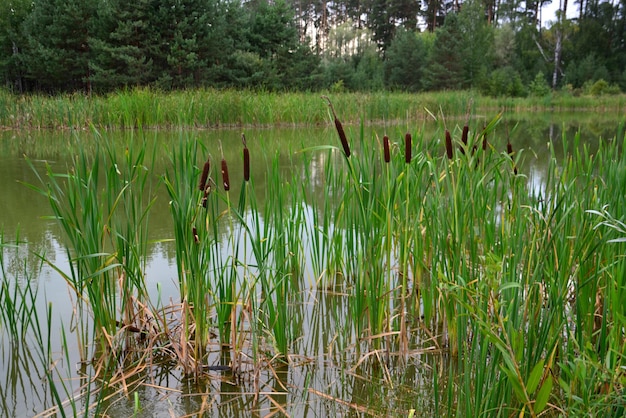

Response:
(0, 96), (626, 416)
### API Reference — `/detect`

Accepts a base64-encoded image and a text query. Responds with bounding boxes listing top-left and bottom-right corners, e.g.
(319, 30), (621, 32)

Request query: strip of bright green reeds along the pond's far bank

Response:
(0, 89), (626, 129)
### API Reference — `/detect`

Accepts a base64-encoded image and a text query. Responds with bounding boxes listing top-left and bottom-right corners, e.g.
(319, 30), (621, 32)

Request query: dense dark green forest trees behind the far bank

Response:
(0, 0), (626, 96)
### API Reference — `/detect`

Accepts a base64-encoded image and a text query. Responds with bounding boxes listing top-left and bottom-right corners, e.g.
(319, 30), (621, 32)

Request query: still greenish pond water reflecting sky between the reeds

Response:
(0, 114), (624, 417)
